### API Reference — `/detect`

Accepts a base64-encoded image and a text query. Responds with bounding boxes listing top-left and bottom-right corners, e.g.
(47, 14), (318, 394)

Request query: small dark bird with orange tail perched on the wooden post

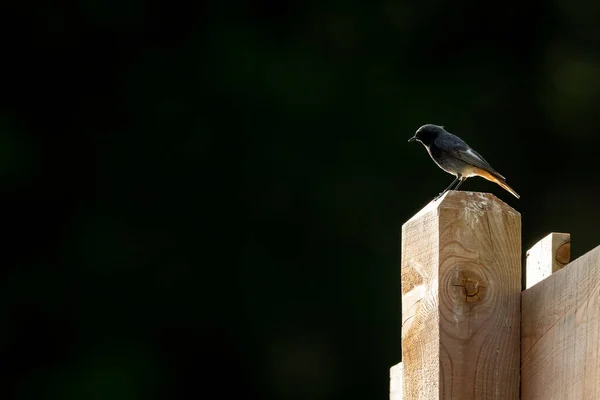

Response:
(408, 124), (520, 200)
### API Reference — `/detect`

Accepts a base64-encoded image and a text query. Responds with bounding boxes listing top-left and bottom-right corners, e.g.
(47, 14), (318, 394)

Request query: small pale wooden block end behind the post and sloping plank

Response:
(525, 232), (571, 289)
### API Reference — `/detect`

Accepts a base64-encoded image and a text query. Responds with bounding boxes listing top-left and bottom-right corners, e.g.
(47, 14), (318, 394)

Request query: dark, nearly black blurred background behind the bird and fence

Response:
(0, 0), (600, 400)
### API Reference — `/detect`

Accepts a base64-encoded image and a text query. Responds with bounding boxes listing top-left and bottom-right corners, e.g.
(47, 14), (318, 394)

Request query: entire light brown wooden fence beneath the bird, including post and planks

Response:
(390, 191), (600, 400)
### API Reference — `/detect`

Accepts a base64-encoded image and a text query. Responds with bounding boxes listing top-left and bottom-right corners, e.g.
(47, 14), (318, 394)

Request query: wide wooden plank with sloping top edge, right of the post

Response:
(521, 242), (600, 400)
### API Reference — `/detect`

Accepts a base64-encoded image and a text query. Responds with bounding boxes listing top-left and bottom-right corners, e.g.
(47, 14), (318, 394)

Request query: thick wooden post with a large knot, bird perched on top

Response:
(401, 191), (521, 400)
